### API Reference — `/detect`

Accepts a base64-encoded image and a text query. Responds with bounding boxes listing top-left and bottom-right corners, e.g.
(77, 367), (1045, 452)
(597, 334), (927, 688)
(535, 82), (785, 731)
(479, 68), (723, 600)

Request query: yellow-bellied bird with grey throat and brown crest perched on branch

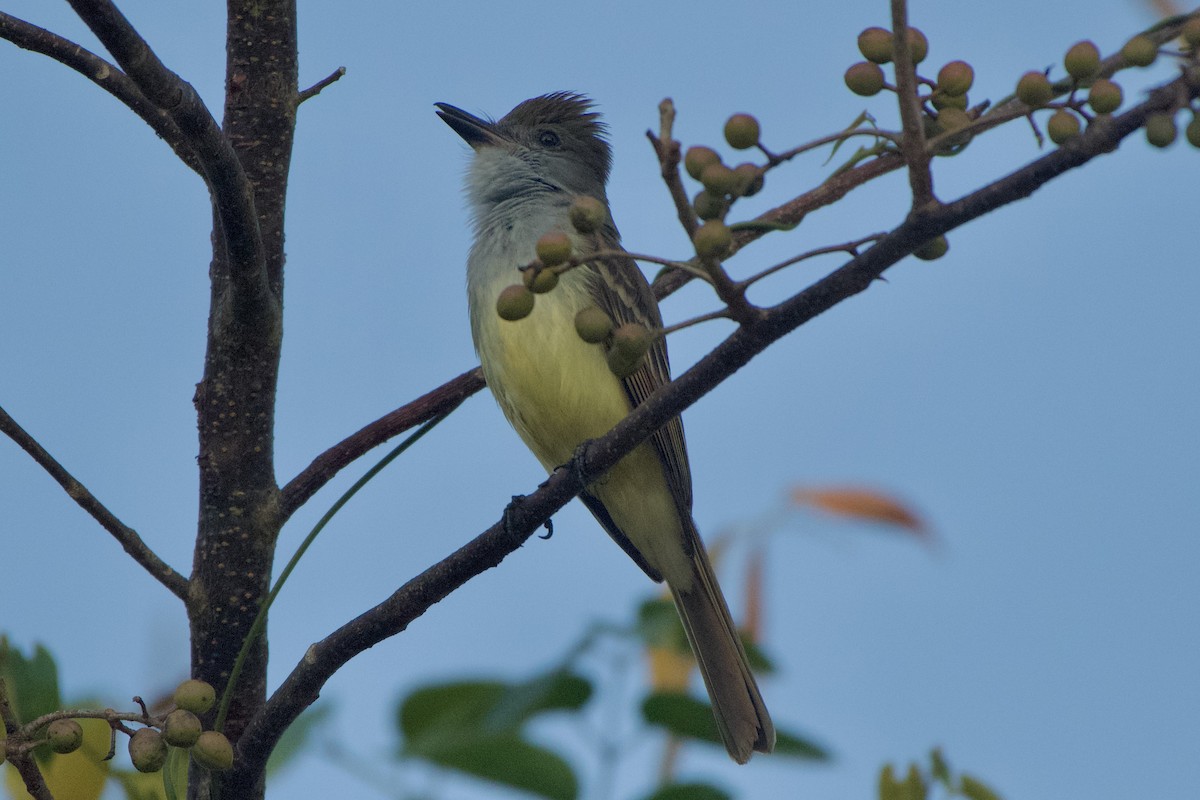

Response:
(436, 91), (775, 764)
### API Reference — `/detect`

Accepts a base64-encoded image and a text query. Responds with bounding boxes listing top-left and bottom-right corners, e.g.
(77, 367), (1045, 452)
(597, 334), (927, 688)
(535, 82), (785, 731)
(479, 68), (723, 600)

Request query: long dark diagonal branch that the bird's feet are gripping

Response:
(235, 71), (1200, 774)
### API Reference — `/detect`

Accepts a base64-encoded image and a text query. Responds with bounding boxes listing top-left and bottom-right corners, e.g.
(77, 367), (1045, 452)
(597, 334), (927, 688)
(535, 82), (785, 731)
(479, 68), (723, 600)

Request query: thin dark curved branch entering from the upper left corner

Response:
(0, 11), (204, 178)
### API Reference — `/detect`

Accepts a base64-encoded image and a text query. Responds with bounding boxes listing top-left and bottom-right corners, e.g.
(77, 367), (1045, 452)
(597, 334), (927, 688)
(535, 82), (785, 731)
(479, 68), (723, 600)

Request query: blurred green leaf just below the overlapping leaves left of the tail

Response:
(425, 733), (578, 800)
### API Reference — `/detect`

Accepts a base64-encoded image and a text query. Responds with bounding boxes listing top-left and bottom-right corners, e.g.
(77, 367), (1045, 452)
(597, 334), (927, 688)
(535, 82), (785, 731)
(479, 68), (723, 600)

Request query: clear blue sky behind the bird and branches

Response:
(0, 0), (1200, 800)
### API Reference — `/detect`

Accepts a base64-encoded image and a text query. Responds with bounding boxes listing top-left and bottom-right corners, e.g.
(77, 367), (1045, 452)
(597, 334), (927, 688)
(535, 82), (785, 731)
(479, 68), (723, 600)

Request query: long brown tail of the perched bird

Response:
(671, 525), (775, 764)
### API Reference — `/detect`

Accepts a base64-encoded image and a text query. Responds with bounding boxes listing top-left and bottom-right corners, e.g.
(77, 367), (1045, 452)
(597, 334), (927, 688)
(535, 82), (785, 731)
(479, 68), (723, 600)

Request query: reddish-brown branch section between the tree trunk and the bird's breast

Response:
(280, 367), (484, 519)
